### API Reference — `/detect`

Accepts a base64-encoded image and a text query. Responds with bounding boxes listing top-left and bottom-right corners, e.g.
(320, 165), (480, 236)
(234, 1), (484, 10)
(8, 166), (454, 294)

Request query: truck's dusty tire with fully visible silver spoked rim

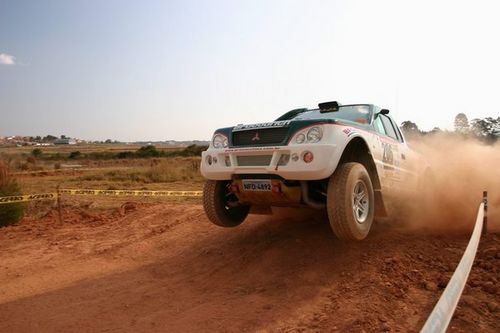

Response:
(326, 162), (375, 240)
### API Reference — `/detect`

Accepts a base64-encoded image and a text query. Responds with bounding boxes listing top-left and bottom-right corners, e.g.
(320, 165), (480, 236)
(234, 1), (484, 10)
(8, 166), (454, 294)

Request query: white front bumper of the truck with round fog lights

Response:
(201, 144), (340, 180)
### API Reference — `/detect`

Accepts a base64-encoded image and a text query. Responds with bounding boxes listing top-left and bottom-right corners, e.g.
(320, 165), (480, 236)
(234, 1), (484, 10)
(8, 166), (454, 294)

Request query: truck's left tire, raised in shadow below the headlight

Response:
(203, 180), (250, 227)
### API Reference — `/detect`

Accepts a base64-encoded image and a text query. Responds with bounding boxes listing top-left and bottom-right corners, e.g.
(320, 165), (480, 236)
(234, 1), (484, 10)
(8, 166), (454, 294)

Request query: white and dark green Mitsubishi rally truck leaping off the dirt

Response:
(201, 102), (423, 240)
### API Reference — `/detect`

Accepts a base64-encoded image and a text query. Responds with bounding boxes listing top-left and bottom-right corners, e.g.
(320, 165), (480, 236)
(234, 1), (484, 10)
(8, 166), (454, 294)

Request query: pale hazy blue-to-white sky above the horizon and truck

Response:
(0, 0), (500, 141)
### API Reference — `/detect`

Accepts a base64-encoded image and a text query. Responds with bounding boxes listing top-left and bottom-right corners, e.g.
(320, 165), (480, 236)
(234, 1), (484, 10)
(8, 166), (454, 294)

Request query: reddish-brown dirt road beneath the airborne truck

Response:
(0, 204), (500, 332)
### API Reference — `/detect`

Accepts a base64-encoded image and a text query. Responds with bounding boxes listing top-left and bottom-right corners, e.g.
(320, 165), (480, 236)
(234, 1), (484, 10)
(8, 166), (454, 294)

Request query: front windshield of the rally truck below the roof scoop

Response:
(292, 104), (372, 124)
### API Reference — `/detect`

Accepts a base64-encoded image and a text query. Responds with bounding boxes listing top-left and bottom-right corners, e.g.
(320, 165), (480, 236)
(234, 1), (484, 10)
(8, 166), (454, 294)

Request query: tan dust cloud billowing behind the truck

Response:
(402, 134), (500, 232)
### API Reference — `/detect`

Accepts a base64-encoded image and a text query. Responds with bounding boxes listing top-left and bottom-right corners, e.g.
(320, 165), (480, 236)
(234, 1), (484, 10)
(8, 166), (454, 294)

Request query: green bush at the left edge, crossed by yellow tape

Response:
(0, 163), (24, 227)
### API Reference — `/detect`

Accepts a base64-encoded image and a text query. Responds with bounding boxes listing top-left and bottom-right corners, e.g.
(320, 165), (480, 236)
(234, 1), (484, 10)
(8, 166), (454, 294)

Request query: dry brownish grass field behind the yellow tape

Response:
(0, 144), (203, 213)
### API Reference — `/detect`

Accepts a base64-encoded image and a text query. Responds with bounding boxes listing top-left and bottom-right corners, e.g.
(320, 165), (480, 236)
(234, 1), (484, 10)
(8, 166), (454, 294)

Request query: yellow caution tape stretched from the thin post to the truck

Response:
(59, 189), (203, 197)
